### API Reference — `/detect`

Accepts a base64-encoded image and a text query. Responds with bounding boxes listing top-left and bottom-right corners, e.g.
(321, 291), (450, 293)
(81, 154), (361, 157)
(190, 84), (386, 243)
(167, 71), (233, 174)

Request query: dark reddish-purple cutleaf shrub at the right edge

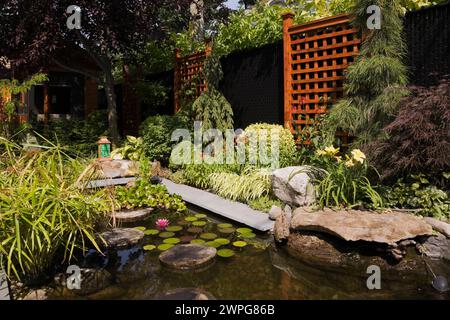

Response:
(368, 79), (450, 188)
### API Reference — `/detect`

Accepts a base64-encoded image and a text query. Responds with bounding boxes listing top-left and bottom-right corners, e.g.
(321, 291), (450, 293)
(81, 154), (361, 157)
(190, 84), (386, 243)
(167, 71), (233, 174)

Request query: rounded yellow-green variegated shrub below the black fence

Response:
(239, 123), (297, 167)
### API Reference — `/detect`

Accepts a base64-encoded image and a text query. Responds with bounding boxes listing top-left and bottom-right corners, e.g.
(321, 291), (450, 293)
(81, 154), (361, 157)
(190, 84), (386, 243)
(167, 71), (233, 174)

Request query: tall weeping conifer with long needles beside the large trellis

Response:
(326, 0), (407, 144)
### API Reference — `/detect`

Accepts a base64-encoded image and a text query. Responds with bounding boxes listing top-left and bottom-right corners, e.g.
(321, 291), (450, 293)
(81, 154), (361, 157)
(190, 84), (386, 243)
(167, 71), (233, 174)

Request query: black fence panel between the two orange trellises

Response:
(220, 42), (283, 128)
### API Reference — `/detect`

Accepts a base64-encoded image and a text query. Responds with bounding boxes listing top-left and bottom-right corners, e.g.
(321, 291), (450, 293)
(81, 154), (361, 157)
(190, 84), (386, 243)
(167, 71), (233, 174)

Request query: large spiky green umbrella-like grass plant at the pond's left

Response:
(0, 138), (112, 284)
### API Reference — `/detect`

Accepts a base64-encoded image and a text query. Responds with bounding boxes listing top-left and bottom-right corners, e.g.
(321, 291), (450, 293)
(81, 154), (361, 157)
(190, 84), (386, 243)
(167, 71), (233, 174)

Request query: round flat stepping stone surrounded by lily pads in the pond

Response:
(159, 244), (217, 270)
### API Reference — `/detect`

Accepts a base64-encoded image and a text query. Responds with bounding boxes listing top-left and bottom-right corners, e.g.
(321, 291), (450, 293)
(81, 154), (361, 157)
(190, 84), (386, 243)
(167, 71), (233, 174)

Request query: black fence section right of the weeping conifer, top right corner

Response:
(404, 3), (450, 86)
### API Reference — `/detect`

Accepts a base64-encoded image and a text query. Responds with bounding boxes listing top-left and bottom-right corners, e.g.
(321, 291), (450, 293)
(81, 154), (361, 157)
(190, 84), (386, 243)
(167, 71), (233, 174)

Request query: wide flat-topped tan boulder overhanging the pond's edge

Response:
(291, 210), (433, 246)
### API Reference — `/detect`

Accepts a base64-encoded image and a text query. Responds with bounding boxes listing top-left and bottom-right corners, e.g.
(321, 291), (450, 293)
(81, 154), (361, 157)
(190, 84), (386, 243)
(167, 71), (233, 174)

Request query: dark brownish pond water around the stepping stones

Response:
(49, 210), (450, 300)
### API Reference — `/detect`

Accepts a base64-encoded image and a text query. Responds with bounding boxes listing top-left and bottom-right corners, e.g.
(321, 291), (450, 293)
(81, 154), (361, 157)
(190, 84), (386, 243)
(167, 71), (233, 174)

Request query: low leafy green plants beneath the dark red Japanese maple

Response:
(384, 173), (450, 220)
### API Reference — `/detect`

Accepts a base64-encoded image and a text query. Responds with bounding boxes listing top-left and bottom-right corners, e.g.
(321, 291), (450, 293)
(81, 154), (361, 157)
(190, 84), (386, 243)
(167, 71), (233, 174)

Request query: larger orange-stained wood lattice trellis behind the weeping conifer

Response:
(283, 13), (361, 146)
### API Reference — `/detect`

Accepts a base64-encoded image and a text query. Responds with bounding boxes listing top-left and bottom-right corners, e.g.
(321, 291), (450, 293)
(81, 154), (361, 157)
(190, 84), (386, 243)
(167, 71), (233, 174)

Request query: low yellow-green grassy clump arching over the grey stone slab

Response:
(209, 170), (271, 202)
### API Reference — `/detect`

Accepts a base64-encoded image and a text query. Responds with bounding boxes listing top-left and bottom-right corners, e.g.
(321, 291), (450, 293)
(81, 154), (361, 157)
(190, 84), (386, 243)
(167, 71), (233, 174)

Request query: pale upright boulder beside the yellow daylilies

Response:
(272, 166), (316, 206)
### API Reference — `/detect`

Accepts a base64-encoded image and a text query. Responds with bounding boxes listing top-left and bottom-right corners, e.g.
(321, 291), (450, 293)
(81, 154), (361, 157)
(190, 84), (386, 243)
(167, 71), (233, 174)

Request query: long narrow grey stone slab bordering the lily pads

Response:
(162, 179), (274, 231)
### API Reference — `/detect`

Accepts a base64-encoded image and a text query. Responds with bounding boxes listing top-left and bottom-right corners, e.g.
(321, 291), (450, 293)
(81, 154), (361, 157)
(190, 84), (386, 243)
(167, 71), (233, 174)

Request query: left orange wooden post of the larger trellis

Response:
(282, 12), (294, 129)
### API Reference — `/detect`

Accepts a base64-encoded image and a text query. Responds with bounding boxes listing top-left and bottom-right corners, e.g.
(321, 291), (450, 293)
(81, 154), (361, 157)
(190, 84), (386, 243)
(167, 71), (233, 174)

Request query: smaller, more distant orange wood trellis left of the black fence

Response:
(173, 40), (211, 113)
